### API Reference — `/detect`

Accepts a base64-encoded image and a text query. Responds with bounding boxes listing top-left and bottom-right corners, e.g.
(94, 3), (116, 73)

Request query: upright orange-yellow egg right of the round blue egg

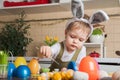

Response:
(28, 58), (39, 74)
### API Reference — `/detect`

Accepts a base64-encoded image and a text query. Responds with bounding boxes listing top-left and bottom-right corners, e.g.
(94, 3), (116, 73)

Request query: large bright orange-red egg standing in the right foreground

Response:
(79, 56), (99, 80)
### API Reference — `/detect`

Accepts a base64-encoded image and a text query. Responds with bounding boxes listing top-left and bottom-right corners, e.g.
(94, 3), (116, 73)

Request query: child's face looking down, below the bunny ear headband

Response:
(65, 29), (88, 52)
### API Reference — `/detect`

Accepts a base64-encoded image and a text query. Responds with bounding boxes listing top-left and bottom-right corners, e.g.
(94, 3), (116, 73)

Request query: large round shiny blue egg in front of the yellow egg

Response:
(15, 65), (31, 78)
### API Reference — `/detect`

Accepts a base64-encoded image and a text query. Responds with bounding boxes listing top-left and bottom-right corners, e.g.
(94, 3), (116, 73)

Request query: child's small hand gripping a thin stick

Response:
(39, 46), (51, 58)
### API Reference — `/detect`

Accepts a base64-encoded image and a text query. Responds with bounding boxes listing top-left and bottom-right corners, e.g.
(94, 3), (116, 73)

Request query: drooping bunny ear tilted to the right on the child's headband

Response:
(89, 10), (109, 24)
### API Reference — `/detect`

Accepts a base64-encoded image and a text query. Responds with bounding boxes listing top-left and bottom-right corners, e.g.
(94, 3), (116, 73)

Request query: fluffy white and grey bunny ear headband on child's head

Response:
(66, 0), (109, 36)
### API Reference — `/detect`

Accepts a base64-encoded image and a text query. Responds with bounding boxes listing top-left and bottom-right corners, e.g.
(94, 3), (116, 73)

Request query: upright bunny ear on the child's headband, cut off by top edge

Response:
(71, 0), (84, 19)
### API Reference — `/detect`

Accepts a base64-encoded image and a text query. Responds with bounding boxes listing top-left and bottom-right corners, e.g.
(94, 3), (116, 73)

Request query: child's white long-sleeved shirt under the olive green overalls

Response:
(51, 43), (86, 65)
